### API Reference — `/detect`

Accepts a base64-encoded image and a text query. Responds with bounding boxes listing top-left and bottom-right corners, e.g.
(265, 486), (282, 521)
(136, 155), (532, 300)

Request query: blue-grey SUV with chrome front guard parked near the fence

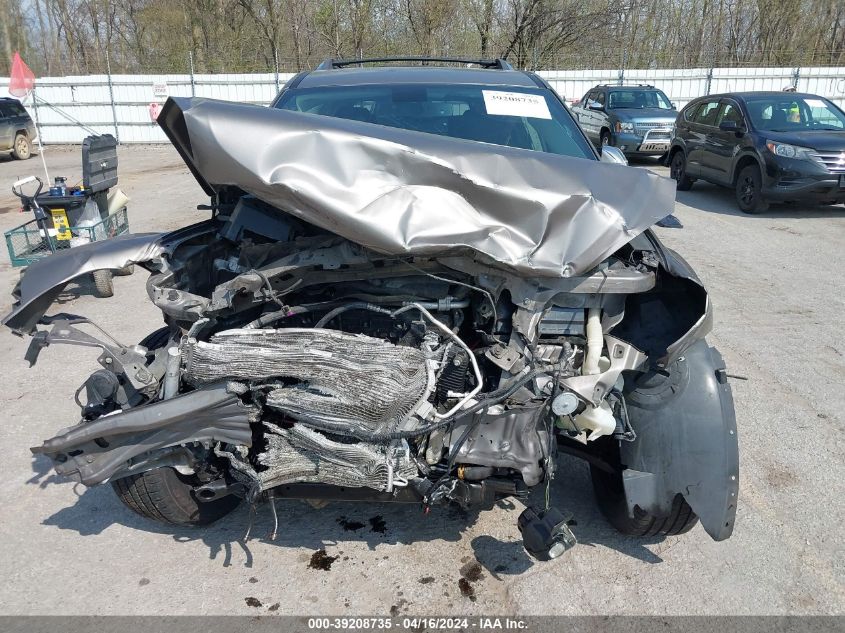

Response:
(572, 84), (678, 156)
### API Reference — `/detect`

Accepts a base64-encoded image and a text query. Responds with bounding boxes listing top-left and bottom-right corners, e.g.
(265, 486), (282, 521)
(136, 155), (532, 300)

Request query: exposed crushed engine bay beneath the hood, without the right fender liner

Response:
(23, 199), (728, 540)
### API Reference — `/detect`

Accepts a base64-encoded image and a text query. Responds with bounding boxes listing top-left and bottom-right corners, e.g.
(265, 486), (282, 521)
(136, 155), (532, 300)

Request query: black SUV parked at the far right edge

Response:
(668, 92), (845, 213)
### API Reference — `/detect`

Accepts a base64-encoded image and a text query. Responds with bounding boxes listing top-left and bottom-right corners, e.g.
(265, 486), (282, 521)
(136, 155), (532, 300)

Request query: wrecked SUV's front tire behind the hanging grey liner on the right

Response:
(590, 465), (698, 536)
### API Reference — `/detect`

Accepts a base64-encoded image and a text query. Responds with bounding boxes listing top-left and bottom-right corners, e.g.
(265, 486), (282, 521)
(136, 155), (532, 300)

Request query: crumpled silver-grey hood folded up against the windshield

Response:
(158, 98), (675, 277)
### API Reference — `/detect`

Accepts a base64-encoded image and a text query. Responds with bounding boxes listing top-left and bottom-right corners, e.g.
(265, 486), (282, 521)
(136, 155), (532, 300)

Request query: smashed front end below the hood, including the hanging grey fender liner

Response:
(4, 96), (736, 557)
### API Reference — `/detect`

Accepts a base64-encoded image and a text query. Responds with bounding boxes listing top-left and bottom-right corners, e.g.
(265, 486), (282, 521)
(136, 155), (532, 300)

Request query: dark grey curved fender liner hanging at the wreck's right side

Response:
(621, 339), (739, 541)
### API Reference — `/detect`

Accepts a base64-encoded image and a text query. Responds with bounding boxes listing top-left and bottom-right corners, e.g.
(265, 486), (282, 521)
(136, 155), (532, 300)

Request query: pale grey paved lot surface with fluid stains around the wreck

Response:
(0, 147), (845, 615)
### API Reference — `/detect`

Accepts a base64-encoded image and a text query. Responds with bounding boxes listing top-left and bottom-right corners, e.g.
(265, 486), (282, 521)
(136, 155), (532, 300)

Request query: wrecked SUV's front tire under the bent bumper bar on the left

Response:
(112, 467), (241, 526)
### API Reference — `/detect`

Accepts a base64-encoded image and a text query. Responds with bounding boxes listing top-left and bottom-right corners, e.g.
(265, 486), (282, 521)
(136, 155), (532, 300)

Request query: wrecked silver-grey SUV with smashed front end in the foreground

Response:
(4, 68), (738, 558)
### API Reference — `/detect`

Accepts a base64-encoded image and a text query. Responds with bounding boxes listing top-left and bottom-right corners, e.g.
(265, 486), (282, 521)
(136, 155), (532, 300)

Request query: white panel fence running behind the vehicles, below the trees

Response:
(0, 67), (845, 143)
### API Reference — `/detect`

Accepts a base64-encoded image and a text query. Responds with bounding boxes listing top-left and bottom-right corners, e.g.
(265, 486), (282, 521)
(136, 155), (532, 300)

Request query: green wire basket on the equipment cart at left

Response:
(5, 207), (129, 266)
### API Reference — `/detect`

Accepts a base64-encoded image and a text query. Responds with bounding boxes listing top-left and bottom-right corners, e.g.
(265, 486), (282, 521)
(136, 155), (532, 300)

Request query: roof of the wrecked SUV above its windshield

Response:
(297, 66), (541, 88)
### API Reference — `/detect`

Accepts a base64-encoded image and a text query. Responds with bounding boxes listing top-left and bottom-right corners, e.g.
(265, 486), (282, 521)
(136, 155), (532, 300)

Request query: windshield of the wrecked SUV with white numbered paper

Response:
(275, 84), (595, 159)
